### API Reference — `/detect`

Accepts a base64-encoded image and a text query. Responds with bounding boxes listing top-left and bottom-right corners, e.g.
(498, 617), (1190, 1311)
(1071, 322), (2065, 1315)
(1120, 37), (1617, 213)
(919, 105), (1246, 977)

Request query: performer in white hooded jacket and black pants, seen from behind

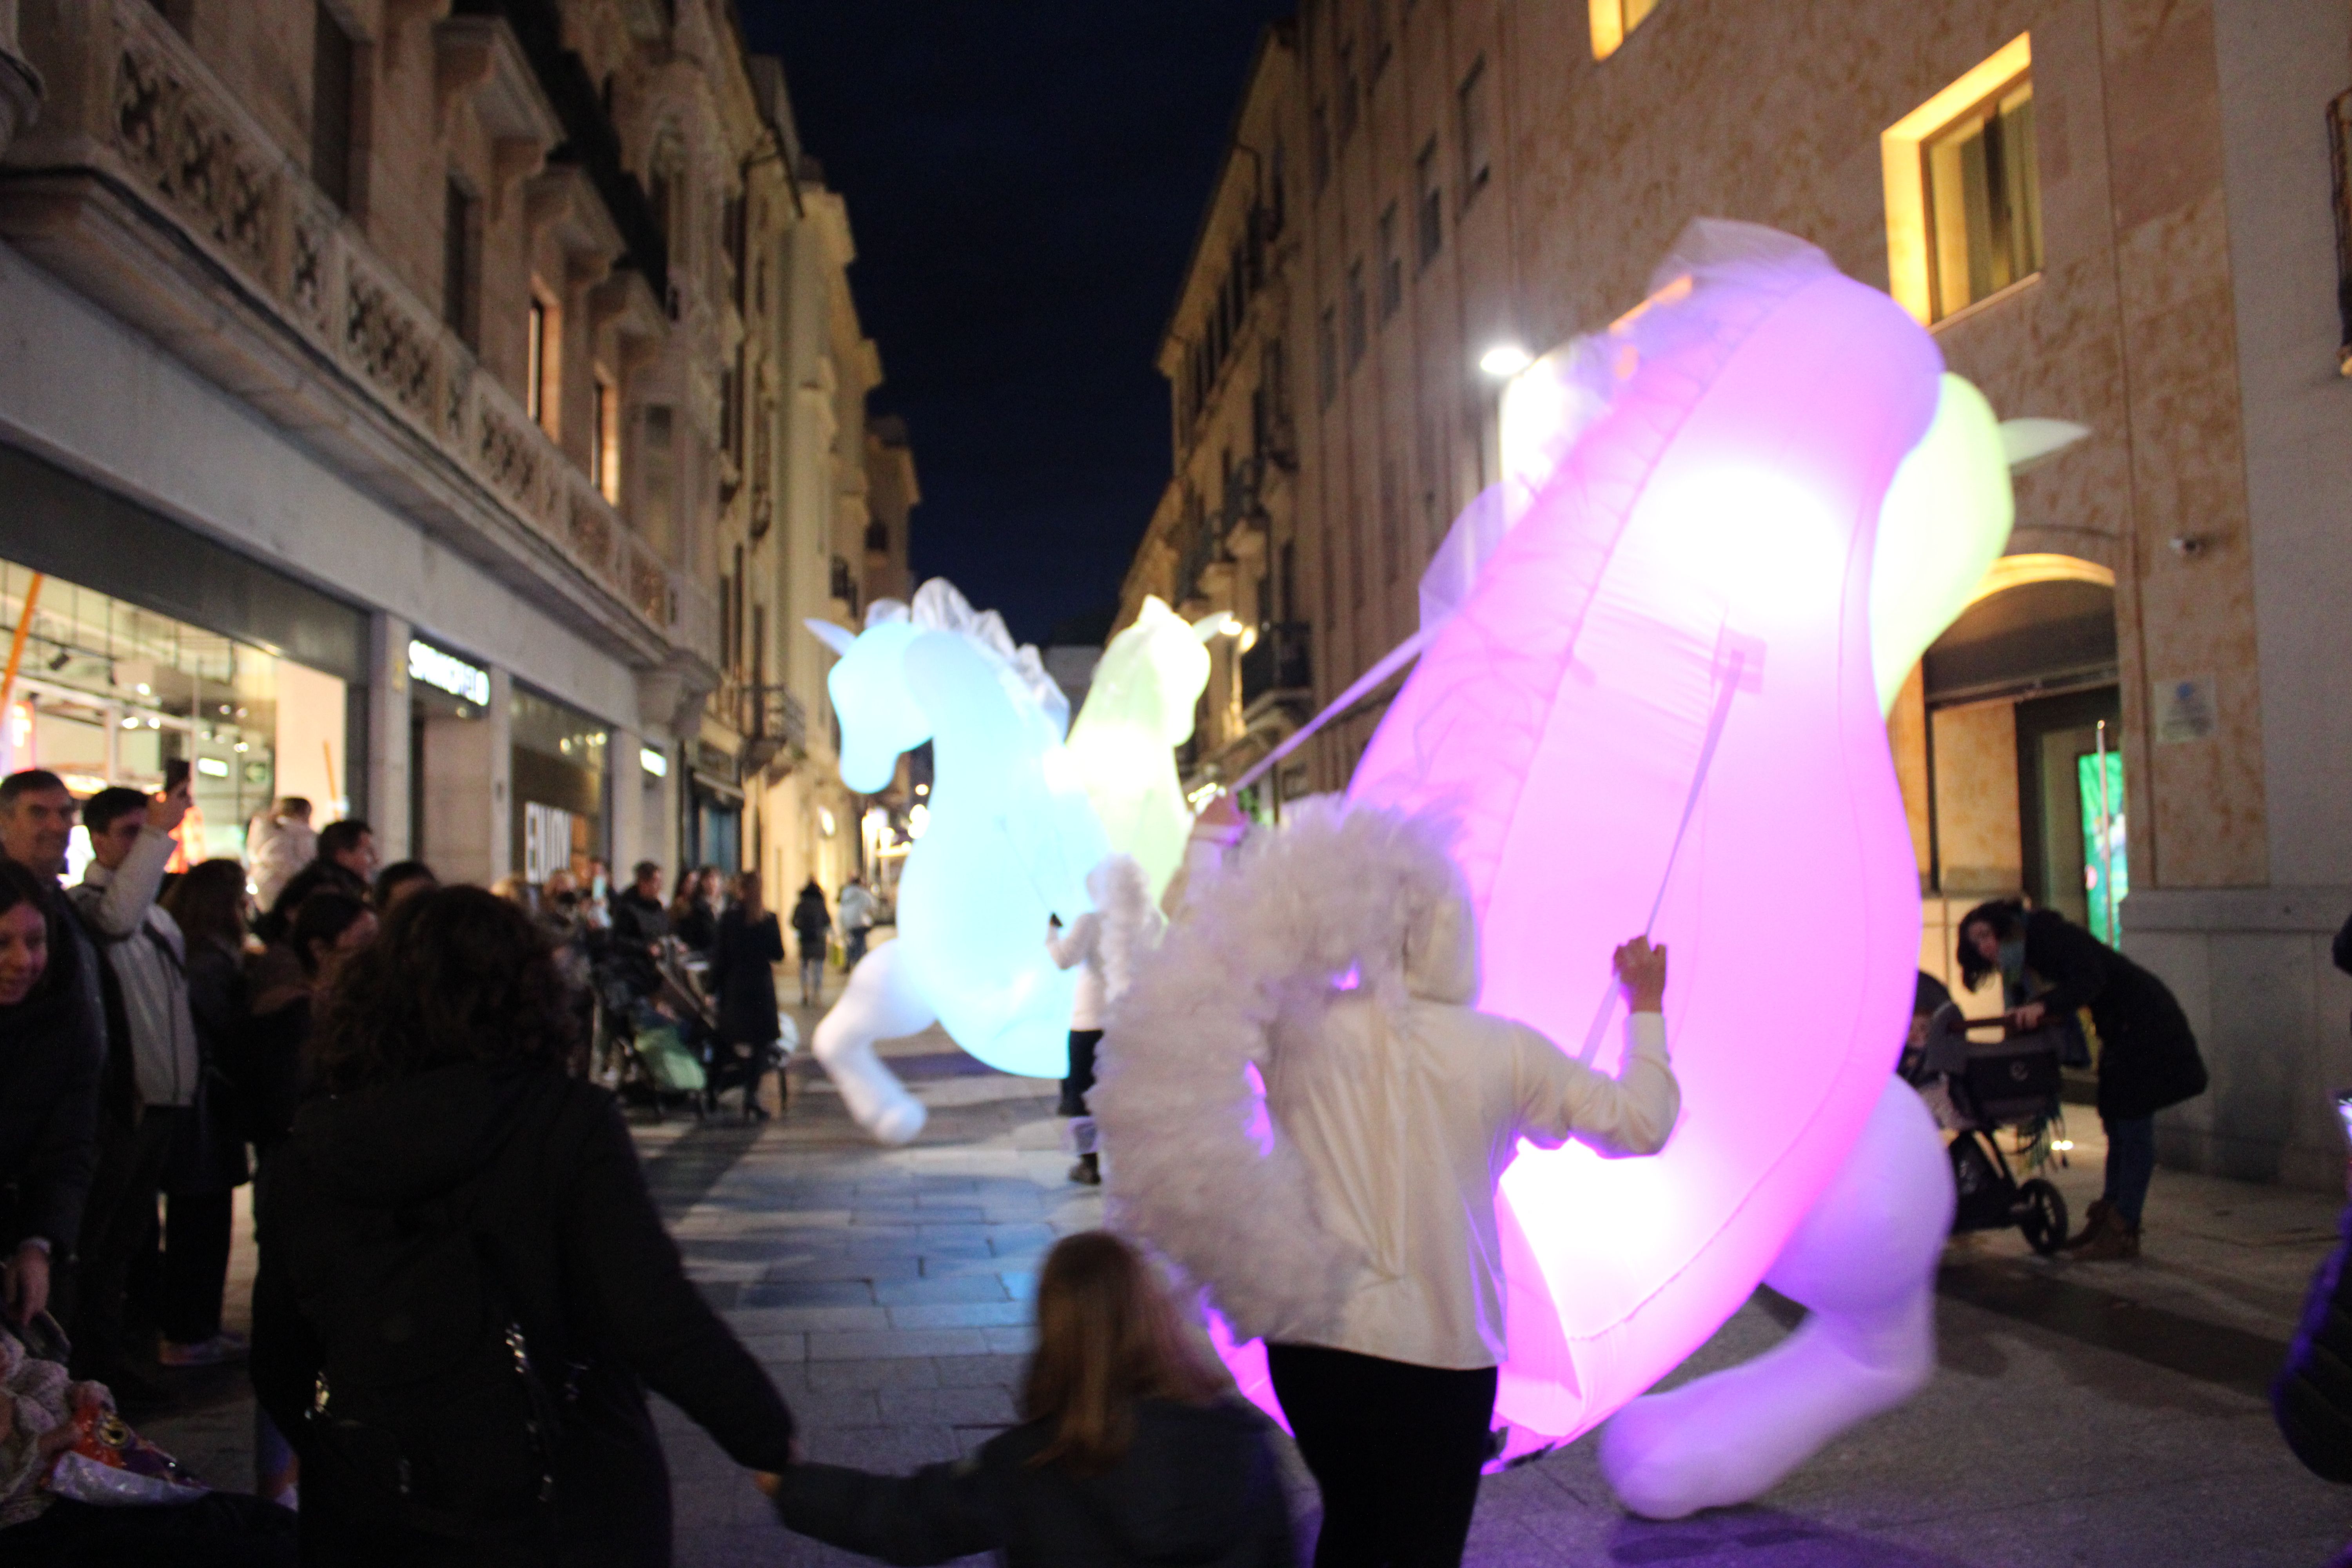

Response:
(1268, 898), (1682, 1566)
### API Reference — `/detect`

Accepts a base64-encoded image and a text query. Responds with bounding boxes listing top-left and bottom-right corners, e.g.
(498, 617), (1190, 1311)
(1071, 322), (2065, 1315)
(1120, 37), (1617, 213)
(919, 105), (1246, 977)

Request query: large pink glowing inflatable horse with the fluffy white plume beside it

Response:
(1098, 223), (2011, 1516)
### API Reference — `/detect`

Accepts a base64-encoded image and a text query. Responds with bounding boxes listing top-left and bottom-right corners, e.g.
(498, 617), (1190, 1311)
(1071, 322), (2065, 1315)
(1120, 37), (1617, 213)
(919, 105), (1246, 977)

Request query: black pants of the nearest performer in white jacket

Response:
(1265, 1345), (1496, 1568)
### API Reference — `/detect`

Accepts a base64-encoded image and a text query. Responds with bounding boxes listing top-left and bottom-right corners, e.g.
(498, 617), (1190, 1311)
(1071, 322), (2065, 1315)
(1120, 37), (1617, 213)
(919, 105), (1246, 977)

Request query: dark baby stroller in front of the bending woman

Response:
(1912, 1002), (2067, 1258)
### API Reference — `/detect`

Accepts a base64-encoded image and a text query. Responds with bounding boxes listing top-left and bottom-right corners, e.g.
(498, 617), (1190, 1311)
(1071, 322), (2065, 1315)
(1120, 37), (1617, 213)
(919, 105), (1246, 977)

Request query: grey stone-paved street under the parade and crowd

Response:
(151, 1001), (2352, 1568)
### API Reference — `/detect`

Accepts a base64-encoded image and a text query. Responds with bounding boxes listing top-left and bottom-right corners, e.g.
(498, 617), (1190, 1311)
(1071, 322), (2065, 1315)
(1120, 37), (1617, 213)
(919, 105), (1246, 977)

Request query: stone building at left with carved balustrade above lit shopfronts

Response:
(0, 0), (898, 912)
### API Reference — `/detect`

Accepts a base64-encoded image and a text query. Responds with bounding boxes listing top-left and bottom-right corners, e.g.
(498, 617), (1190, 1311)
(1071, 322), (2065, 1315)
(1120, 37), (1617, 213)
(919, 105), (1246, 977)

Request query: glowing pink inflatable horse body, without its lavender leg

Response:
(1228, 249), (1943, 1439)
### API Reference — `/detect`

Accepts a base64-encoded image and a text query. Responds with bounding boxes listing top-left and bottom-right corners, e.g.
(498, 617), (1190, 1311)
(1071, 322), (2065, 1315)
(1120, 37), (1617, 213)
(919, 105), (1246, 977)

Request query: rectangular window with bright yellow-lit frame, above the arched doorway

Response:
(1879, 33), (2042, 322)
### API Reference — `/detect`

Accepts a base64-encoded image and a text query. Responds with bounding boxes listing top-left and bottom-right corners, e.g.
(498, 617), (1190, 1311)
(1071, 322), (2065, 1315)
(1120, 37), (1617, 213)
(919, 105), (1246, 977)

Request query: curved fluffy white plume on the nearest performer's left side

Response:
(1091, 802), (1458, 1340)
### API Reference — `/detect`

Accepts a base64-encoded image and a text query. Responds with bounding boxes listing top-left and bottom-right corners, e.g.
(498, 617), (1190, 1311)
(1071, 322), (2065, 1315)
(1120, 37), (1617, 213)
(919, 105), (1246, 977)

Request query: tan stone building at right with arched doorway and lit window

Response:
(1129, 0), (2352, 1185)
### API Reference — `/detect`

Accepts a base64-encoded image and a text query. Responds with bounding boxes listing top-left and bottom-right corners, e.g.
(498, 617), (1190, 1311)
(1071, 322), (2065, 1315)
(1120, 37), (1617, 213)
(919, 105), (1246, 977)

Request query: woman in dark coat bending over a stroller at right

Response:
(1959, 903), (2206, 1260)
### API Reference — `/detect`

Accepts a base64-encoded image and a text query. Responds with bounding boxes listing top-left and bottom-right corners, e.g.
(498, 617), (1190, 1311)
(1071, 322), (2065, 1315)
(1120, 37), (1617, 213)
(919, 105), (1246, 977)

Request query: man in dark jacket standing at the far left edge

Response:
(0, 769), (106, 1321)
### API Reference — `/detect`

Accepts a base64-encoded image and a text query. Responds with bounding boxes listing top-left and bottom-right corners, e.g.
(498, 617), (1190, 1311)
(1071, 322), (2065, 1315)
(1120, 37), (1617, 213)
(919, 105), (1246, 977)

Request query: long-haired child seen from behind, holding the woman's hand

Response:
(771, 1229), (1296, 1568)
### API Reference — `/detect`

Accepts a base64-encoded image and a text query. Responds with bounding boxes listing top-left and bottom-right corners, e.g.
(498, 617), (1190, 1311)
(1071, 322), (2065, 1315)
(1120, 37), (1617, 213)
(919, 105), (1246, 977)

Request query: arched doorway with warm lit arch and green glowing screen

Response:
(1905, 555), (2129, 973)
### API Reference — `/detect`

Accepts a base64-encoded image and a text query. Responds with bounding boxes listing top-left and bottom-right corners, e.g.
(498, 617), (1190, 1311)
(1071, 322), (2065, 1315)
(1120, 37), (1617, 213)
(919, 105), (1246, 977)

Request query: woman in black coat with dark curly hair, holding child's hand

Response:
(254, 886), (793, 1568)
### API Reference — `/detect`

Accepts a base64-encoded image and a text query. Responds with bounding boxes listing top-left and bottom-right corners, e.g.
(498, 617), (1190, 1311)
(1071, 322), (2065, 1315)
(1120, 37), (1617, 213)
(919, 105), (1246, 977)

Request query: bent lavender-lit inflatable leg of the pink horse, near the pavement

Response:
(1602, 1077), (1952, 1519)
